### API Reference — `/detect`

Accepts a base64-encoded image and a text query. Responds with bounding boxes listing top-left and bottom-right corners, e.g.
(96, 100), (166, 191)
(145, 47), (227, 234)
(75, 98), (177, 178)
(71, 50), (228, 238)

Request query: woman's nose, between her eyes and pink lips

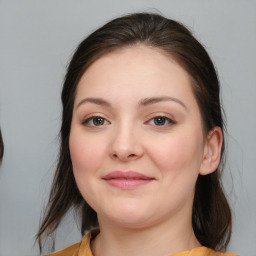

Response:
(110, 126), (144, 162)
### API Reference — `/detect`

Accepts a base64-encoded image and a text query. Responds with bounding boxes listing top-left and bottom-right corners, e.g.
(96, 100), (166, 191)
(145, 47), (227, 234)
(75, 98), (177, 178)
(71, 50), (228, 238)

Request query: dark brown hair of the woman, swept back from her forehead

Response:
(37, 13), (231, 250)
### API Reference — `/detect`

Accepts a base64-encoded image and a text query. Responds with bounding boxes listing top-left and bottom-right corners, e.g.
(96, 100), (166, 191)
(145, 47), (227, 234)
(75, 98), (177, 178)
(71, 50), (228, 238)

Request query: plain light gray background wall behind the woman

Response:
(0, 0), (256, 256)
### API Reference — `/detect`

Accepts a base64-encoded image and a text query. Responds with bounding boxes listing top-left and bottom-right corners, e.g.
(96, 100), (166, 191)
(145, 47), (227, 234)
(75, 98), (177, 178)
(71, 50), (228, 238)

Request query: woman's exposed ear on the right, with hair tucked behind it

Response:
(199, 127), (223, 175)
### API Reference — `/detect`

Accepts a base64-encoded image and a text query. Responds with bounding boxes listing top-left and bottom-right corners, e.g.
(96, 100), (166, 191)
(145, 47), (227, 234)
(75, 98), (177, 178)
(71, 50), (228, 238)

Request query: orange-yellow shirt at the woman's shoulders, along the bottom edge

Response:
(48, 230), (238, 256)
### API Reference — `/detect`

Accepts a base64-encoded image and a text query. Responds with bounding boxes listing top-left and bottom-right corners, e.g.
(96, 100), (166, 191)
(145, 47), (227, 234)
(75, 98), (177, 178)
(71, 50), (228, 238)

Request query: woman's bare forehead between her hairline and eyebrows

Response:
(76, 45), (196, 105)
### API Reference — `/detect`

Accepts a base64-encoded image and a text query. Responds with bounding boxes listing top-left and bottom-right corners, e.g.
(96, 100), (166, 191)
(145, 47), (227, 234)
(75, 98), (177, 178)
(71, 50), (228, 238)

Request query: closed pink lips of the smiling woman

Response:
(102, 171), (155, 189)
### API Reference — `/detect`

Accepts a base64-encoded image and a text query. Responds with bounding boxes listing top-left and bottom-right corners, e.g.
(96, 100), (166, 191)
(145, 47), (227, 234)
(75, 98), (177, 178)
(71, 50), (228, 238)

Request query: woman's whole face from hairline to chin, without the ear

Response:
(69, 46), (205, 227)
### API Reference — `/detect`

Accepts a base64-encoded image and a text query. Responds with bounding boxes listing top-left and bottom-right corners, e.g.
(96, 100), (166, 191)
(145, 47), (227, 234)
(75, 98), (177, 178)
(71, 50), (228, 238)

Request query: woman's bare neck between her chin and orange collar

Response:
(92, 214), (200, 256)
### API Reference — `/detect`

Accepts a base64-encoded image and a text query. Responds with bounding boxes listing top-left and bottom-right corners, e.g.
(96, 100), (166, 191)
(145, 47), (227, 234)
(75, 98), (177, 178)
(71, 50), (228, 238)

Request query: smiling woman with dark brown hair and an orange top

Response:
(37, 13), (239, 256)
